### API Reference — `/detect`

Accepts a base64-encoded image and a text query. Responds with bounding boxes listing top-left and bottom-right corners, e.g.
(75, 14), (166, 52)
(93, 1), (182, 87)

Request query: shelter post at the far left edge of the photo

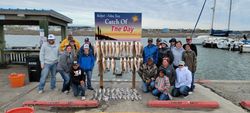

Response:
(0, 24), (5, 66)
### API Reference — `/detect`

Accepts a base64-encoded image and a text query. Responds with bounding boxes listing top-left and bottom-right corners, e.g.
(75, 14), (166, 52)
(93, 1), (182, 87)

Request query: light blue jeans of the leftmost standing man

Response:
(38, 63), (57, 91)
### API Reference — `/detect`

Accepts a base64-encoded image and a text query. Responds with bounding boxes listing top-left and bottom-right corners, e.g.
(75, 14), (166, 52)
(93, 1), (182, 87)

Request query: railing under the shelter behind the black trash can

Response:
(4, 49), (40, 64)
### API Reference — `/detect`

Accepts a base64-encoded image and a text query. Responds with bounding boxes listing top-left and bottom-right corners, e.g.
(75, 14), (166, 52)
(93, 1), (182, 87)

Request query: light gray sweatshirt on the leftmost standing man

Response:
(39, 43), (59, 65)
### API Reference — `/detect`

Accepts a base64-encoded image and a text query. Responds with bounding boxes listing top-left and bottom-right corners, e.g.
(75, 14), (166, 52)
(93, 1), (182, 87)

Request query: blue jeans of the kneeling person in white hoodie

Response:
(172, 86), (190, 97)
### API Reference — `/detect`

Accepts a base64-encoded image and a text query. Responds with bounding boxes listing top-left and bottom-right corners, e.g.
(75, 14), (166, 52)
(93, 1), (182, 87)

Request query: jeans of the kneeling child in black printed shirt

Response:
(71, 83), (86, 97)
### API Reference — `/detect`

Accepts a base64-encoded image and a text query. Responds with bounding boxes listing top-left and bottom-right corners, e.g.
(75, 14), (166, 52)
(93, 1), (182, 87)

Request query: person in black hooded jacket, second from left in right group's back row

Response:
(157, 41), (174, 67)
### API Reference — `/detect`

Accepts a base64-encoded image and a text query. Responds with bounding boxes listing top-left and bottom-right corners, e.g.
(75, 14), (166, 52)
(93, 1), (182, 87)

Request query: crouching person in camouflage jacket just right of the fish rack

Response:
(138, 58), (157, 93)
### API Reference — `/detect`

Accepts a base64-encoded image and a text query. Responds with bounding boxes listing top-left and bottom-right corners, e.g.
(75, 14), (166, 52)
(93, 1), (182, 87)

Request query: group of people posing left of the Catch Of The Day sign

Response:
(38, 34), (95, 100)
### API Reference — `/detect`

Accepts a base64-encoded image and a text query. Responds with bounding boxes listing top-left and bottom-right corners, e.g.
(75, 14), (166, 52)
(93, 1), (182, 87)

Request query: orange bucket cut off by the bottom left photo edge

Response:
(5, 107), (35, 113)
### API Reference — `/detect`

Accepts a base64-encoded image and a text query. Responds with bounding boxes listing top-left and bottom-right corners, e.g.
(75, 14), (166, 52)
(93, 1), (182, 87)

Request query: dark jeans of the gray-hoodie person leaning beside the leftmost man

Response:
(58, 70), (70, 92)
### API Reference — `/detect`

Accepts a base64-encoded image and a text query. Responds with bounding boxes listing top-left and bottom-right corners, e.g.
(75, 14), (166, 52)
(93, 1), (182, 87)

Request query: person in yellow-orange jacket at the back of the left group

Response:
(60, 34), (80, 52)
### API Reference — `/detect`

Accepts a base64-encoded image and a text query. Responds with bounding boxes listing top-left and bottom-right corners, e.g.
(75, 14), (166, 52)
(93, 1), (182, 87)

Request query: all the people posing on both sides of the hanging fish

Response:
(38, 34), (197, 100)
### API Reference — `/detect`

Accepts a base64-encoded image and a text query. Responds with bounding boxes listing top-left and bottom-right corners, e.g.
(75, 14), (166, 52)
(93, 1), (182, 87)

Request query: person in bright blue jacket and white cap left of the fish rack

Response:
(78, 44), (95, 90)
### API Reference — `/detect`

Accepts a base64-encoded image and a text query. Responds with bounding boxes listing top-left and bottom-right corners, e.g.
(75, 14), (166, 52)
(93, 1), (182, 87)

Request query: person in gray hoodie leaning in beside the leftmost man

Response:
(57, 45), (74, 94)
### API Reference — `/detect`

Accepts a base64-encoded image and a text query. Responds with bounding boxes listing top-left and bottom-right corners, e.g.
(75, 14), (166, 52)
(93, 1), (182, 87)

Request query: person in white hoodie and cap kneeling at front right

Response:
(172, 61), (192, 97)
